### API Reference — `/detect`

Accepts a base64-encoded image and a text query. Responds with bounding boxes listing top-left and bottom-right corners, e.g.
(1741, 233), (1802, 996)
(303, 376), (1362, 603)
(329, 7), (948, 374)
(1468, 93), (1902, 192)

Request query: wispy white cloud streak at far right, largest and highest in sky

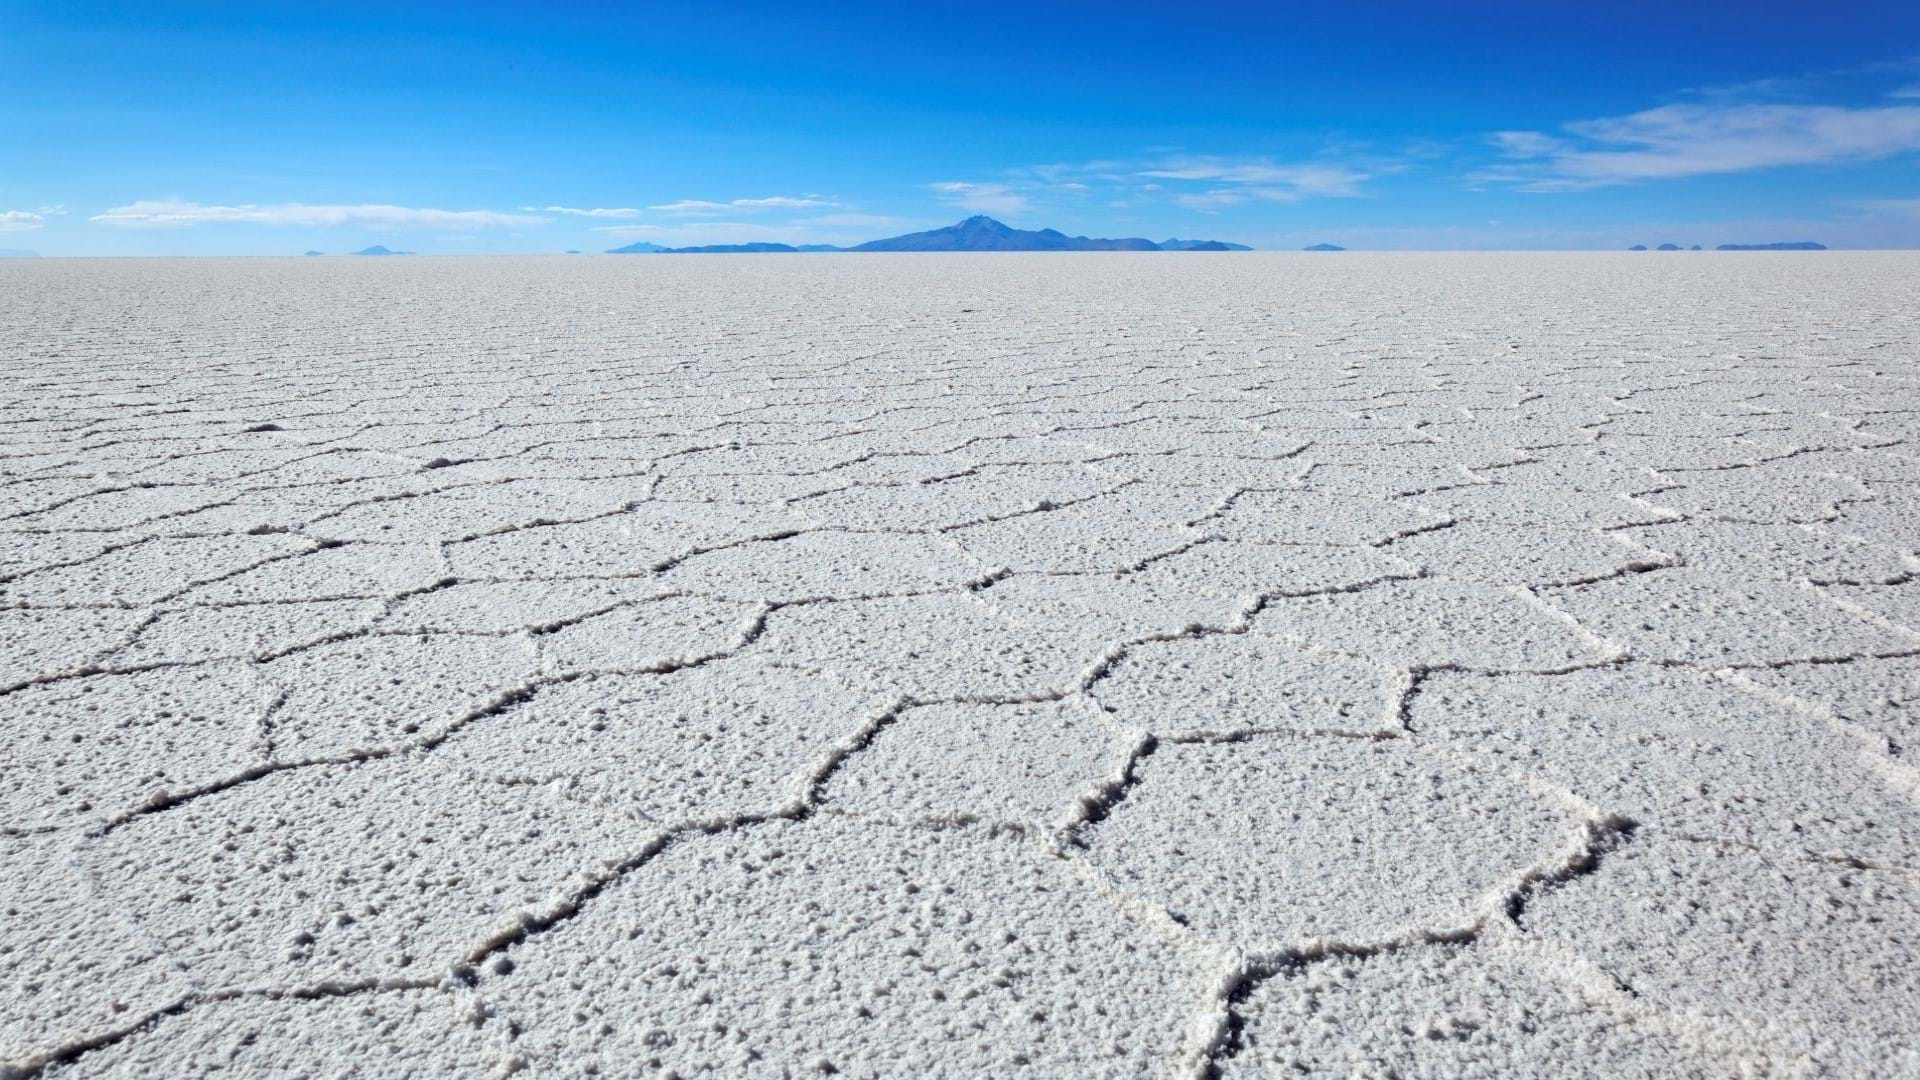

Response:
(1471, 104), (1920, 192)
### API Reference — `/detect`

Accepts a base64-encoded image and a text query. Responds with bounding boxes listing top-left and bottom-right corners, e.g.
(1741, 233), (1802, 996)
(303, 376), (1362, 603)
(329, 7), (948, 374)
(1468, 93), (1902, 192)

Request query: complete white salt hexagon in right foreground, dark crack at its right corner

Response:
(1085, 736), (1576, 949)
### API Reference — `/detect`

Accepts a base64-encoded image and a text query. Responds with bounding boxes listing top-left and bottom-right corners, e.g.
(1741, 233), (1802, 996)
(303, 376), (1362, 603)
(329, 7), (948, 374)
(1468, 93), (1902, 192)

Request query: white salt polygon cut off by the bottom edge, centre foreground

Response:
(478, 815), (1204, 1076)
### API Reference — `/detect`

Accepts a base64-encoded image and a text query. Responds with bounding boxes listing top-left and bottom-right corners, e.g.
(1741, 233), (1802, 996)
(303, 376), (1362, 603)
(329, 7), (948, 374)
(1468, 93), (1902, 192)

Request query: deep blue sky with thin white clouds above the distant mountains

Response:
(0, 0), (1920, 256)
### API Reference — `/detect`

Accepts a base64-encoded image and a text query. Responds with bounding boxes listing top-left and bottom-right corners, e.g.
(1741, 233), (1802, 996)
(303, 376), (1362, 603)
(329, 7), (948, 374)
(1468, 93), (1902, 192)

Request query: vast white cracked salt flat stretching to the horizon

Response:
(0, 252), (1920, 1078)
